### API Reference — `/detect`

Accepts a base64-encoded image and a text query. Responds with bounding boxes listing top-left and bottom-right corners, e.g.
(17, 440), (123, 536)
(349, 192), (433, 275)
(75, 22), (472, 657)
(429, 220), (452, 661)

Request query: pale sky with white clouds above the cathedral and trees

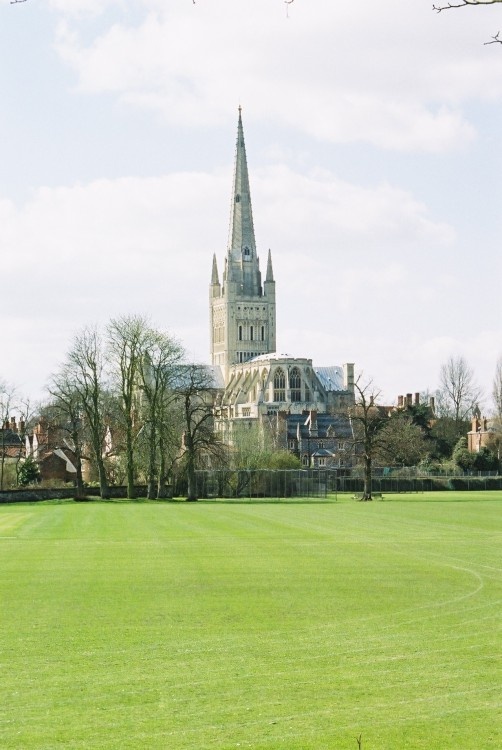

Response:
(0, 0), (502, 411)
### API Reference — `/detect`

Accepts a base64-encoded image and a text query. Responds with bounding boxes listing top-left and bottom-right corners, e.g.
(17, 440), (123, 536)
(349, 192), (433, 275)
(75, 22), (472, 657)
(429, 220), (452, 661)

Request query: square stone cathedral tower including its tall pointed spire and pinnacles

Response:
(209, 107), (276, 383)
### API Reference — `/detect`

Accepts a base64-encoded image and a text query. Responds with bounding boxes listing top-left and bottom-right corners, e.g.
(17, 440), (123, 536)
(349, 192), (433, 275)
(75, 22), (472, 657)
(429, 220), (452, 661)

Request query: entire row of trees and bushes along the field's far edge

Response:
(0, 344), (502, 500)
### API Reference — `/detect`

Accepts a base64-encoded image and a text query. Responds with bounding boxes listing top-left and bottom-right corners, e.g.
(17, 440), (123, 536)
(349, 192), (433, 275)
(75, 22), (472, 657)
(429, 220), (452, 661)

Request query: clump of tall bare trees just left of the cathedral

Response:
(43, 316), (225, 500)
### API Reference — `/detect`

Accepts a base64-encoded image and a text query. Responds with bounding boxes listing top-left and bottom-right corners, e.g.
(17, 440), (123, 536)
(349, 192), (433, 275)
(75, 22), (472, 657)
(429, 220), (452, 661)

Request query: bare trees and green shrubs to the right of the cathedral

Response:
(350, 356), (502, 500)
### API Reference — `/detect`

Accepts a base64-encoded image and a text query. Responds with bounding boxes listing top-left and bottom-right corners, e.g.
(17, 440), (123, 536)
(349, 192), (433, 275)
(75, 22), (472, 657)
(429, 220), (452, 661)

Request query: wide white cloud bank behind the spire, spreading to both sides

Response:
(0, 166), (452, 400)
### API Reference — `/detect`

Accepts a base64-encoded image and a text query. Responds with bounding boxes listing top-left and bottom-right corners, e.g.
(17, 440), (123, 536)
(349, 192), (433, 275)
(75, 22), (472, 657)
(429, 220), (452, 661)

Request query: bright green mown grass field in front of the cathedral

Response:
(0, 492), (502, 750)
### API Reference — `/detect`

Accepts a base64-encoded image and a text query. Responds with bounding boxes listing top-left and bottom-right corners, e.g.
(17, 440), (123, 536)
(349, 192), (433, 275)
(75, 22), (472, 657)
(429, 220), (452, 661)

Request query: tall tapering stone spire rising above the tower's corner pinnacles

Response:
(228, 107), (256, 261)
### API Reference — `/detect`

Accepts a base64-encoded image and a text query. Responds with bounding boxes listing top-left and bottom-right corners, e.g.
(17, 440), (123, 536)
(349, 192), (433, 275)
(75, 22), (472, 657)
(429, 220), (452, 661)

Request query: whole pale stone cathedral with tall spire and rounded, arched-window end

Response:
(209, 108), (354, 466)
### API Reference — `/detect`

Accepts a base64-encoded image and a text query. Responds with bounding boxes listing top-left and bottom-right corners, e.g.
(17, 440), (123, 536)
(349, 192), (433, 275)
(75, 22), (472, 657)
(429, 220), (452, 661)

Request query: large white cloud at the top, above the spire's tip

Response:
(49, 0), (502, 152)
